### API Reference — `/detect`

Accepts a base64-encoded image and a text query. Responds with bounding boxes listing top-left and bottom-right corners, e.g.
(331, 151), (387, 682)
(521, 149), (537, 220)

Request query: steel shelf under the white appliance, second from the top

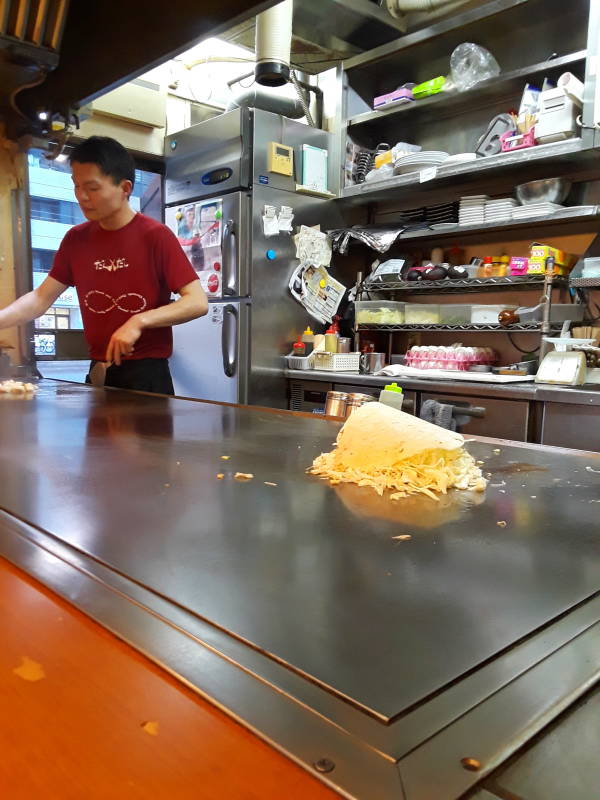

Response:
(341, 138), (597, 205)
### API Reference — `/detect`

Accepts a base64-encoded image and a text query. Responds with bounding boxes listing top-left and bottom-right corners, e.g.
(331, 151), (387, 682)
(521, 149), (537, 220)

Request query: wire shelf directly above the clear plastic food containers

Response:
(361, 275), (568, 294)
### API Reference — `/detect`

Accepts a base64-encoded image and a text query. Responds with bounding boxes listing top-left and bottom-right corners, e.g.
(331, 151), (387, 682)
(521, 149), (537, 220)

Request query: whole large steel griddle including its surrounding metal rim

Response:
(0, 381), (600, 800)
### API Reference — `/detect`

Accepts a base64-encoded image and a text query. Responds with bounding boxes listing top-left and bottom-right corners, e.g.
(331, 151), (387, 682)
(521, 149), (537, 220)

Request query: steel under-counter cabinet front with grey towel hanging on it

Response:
(421, 393), (529, 442)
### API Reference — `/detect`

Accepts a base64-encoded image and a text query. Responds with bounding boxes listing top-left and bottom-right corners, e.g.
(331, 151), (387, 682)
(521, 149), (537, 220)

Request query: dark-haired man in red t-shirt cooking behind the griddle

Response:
(0, 136), (208, 394)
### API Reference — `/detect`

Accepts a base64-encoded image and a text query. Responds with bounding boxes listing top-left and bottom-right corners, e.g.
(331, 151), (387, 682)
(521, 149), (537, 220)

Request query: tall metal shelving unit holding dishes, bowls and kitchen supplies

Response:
(338, 0), (600, 362)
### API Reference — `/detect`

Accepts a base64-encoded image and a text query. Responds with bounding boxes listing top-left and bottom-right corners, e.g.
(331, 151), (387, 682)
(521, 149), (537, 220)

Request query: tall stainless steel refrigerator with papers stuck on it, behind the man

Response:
(165, 109), (341, 408)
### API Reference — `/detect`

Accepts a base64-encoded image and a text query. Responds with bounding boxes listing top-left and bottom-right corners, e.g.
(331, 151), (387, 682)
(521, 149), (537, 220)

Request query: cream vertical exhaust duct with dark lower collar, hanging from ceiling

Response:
(254, 0), (294, 86)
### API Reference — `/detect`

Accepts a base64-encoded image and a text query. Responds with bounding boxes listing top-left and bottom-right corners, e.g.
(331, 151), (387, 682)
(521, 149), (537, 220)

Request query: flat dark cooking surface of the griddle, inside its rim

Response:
(0, 382), (600, 719)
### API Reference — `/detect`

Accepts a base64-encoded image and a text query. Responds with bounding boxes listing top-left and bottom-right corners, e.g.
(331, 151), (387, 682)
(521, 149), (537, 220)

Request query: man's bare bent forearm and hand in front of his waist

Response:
(106, 280), (208, 364)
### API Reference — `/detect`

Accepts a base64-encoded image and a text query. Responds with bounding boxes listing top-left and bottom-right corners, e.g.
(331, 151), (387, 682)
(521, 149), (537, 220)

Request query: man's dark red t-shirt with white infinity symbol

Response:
(50, 214), (198, 361)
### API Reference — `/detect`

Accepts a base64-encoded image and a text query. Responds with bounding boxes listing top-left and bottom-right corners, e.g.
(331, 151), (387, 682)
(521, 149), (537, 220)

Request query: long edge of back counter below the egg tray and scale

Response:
(284, 369), (600, 406)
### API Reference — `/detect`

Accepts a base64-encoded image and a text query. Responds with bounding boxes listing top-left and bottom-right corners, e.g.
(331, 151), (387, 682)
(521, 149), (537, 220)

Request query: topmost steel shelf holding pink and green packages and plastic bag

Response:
(347, 50), (587, 129)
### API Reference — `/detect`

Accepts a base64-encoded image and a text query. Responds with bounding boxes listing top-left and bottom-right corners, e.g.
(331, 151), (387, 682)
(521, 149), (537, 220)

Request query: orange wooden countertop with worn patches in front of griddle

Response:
(0, 558), (338, 800)
